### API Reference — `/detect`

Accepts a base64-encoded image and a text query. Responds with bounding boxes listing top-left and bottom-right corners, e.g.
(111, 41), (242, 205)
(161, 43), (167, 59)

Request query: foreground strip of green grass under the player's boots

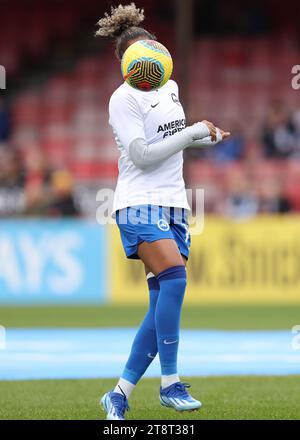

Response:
(0, 376), (300, 420)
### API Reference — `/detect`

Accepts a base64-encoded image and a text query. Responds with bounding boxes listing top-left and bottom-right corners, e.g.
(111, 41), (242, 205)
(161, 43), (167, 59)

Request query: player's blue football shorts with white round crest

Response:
(116, 205), (191, 259)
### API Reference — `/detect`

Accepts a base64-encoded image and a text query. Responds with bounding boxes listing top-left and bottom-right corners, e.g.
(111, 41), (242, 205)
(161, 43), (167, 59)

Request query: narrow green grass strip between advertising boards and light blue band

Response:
(0, 304), (300, 330)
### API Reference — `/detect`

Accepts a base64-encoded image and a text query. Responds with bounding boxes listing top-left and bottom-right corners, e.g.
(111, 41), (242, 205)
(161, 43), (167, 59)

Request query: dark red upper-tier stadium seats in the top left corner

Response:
(0, 0), (159, 76)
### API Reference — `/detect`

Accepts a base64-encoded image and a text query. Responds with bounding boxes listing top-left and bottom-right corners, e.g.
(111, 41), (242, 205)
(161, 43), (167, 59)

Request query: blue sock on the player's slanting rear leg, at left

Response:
(122, 277), (159, 384)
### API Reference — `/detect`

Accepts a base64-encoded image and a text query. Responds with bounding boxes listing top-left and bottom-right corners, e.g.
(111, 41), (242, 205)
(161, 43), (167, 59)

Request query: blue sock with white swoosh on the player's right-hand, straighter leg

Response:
(155, 266), (186, 375)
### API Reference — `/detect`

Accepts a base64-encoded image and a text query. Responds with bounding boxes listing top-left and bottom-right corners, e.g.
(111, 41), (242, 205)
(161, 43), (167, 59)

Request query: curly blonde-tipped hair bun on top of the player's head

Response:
(96, 3), (144, 38)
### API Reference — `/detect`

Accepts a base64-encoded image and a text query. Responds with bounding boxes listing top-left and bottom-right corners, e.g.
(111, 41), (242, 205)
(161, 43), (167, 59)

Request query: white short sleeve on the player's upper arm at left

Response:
(109, 90), (146, 150)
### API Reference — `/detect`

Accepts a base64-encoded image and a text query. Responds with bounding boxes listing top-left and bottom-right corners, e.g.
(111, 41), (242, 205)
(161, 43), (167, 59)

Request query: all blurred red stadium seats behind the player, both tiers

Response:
(0, 0), (300, 209)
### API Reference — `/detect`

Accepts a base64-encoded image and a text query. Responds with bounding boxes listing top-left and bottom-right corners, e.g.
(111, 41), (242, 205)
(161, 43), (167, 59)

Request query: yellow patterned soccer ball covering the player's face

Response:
(121, 40), (173, 92)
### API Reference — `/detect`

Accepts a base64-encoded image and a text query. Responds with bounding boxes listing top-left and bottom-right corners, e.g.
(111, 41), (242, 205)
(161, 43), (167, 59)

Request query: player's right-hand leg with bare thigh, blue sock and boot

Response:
(138, 240), (201, 411)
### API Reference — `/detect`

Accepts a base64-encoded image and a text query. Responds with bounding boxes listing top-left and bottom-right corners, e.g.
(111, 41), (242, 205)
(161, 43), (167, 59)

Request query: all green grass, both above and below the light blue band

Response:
(0, 305), (300, 420)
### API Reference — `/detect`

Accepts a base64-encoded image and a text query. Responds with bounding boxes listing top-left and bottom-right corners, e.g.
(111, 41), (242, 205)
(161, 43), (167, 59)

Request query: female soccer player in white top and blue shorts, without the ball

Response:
(96, 3), (230, 420)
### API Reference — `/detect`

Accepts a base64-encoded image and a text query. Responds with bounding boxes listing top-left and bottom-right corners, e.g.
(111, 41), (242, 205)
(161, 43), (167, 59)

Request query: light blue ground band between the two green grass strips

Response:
(0, 328), (300, 380)
